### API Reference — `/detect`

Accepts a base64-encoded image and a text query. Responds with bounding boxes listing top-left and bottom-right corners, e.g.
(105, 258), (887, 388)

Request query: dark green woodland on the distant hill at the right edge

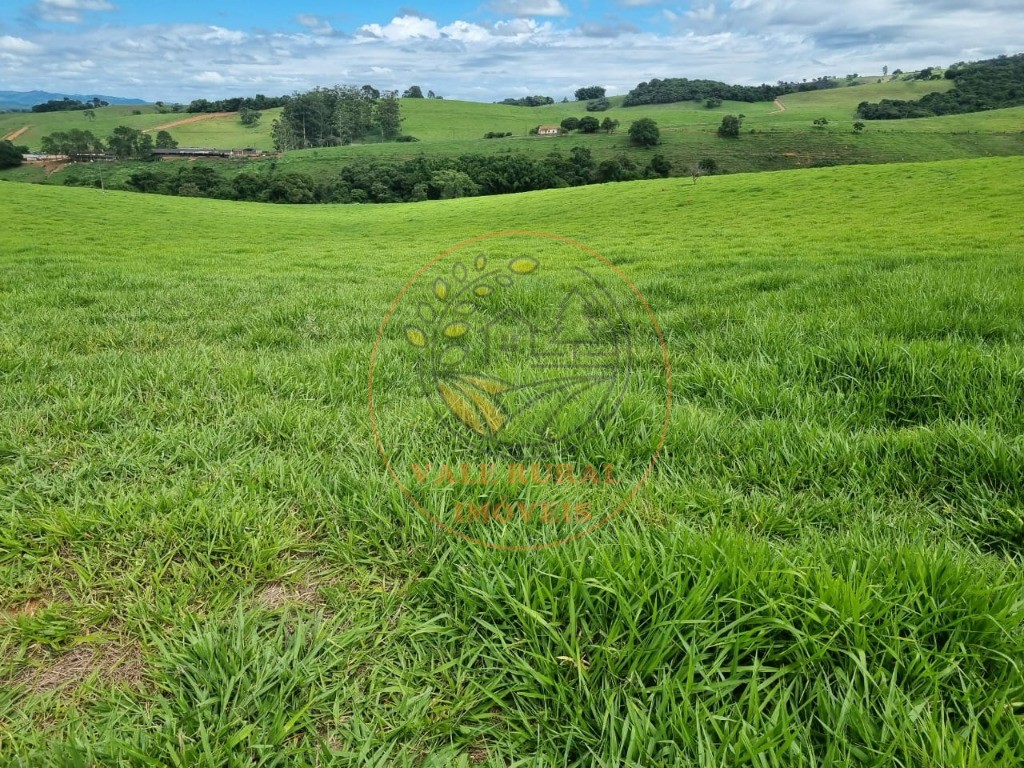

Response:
(857, 53), (1024, 120)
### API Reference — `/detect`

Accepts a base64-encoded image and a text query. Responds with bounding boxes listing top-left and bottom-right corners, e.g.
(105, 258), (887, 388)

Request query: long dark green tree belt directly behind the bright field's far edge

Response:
(65, 146), (684, 204)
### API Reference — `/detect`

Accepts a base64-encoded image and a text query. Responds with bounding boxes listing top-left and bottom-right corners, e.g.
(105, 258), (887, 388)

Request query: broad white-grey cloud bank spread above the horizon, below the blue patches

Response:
(0, 6), (1024, 101)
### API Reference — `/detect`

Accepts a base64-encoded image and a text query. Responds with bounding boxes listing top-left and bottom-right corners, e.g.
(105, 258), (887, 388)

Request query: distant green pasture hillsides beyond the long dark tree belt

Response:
(8, 78), (1024, 195)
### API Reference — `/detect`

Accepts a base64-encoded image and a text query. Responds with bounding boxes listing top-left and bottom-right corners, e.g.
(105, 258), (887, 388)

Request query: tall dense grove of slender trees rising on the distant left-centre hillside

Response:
(271, 85), (402, 152)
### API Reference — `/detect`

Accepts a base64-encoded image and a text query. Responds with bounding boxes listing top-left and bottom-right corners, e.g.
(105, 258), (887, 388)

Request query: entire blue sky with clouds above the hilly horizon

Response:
(0, 0), (1024, 101)
